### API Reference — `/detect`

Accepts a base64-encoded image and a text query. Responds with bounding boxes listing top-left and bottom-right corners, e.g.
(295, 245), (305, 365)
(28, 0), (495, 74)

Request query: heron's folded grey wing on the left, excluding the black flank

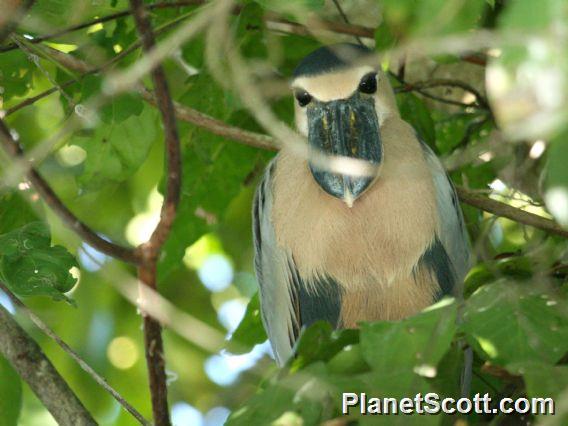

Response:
(252, 160), (299, 365)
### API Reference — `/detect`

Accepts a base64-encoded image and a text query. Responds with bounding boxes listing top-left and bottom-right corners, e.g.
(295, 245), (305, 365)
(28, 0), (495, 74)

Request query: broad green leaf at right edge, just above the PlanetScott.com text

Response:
(462, 281), (568, 365)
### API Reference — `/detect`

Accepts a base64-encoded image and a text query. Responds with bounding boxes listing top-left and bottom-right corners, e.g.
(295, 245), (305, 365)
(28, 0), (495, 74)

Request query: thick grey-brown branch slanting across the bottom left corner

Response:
(0, 305), (97, 426)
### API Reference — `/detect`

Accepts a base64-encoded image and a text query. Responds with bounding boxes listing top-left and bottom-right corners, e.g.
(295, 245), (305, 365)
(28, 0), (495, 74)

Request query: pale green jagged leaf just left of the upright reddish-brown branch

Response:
(70, 101), (156, 189)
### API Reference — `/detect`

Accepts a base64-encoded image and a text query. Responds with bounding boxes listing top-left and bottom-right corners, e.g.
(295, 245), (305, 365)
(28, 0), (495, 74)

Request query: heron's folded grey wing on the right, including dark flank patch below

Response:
(421, 141), (471, 294)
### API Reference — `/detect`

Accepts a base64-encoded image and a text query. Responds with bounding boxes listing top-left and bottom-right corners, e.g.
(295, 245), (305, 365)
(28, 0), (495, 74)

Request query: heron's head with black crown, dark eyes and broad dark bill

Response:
(291, 43), (398, 207)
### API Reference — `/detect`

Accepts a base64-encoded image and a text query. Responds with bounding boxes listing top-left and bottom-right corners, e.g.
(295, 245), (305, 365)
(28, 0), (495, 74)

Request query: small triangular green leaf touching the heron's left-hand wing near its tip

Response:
(227, 293), (267, 354)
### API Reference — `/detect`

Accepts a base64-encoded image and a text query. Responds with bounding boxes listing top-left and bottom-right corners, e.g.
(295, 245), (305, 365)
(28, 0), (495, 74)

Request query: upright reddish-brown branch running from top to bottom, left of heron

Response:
(130, 0), (181, 426)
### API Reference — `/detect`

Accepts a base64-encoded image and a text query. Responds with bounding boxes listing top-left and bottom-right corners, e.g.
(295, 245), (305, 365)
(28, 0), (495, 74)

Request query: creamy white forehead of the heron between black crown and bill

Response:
(291, 65), (377, 102)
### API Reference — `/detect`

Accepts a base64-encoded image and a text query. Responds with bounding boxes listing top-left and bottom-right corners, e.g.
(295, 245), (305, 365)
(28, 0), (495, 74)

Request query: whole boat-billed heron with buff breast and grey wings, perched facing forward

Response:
(253, 44), (470, 364)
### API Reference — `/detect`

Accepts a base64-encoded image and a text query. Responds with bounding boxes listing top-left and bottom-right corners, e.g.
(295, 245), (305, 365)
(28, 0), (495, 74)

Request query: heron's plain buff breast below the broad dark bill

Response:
(272, 120), (438, 292)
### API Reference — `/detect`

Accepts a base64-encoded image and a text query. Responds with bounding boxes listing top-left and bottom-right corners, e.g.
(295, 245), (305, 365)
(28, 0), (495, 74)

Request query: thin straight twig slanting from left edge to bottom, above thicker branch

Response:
(0, 282), (151, 426)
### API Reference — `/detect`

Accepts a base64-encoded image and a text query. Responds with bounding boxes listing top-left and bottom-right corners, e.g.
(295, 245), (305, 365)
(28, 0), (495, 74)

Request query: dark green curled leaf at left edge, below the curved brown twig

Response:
(0, 222), (77, 300)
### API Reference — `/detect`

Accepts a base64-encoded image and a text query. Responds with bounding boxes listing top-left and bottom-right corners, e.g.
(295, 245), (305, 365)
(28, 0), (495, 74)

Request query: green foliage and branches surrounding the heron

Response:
(0, 0), (568, 426)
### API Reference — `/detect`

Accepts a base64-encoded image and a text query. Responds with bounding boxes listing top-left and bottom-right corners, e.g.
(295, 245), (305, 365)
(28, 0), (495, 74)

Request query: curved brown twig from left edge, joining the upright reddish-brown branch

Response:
(0, 119), (138, 263)
